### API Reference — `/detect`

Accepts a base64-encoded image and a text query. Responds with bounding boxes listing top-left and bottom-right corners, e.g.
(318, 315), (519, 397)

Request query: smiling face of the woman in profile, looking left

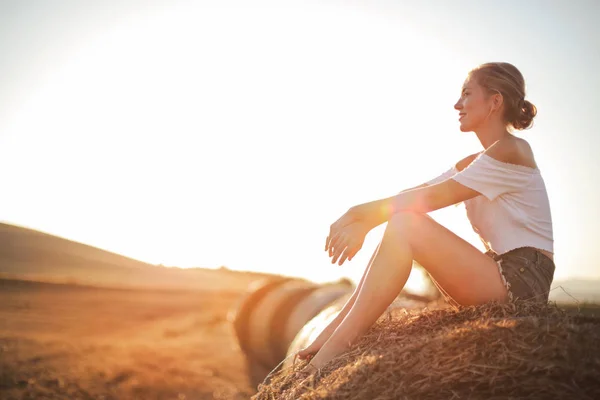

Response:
(454, 78), (492, 132)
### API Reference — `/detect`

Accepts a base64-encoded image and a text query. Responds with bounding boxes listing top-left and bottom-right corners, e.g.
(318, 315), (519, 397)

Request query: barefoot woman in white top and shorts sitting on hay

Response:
(298, 63), (555, 372)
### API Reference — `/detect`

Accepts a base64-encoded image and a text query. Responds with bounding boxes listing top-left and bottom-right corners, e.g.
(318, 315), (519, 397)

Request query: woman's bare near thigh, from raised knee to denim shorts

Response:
(388, 213), (508, 305)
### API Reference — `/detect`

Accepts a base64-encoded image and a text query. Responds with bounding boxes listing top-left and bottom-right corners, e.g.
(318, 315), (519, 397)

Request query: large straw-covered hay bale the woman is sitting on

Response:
(253, 301), (600, 400)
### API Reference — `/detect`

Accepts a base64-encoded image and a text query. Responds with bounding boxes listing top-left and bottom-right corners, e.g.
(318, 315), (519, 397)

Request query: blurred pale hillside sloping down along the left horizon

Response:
(0, 223), (273, 291)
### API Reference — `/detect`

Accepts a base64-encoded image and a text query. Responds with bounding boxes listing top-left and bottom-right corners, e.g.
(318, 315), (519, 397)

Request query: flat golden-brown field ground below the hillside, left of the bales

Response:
(0, 280), (255, 400)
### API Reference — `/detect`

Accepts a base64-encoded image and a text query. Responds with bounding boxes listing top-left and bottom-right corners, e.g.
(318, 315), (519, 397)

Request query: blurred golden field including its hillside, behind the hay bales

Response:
(0, 224), (600, 400)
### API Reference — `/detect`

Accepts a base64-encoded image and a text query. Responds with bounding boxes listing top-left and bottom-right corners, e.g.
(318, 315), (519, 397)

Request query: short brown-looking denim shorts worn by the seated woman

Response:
(485, 247), (555, 303)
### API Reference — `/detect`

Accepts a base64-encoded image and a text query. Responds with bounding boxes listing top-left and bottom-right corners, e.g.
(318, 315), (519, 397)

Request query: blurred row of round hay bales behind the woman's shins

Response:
(229, 278), (353, 378)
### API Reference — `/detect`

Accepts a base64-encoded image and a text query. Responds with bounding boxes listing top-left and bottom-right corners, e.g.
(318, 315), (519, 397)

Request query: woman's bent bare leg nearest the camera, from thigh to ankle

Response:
(311, 212), (507, 368)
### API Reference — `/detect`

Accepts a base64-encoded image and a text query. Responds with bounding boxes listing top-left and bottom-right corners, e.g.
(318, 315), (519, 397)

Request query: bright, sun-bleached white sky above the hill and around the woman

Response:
(0, 0), (600, 288)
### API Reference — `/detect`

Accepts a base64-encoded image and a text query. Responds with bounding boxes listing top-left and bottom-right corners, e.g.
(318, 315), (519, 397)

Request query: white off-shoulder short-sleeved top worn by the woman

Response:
(427, 153), (554, 254)
